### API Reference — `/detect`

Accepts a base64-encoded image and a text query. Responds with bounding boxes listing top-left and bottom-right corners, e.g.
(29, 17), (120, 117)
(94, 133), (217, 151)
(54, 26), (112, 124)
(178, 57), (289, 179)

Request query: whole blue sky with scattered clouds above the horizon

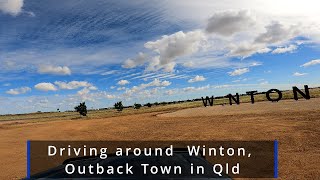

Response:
(0, 0), (320, 114)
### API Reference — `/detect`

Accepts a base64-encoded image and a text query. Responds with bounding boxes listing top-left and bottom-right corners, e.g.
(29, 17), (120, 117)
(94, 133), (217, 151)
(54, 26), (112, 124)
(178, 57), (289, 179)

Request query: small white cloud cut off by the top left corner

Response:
(0, 0), (23, 16)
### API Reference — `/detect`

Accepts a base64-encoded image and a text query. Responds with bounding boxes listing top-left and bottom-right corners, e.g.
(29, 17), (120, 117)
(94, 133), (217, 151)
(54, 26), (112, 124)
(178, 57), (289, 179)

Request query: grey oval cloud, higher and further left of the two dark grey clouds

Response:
(206, 10), (255, 36)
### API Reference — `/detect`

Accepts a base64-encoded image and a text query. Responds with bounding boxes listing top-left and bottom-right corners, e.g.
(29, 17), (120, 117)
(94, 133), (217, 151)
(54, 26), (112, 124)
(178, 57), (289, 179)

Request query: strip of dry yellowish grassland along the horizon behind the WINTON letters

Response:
(0, 87), (320, 122)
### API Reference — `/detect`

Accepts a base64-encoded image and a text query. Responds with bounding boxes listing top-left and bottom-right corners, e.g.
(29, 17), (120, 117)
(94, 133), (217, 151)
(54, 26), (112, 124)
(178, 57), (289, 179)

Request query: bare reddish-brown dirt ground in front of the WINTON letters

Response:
(0, 98), (320, 179)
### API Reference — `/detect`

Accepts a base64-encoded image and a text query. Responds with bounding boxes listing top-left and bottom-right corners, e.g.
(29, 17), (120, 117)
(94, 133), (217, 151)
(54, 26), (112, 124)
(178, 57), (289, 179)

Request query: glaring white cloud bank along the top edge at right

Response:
(167, 0), (320, 27)
